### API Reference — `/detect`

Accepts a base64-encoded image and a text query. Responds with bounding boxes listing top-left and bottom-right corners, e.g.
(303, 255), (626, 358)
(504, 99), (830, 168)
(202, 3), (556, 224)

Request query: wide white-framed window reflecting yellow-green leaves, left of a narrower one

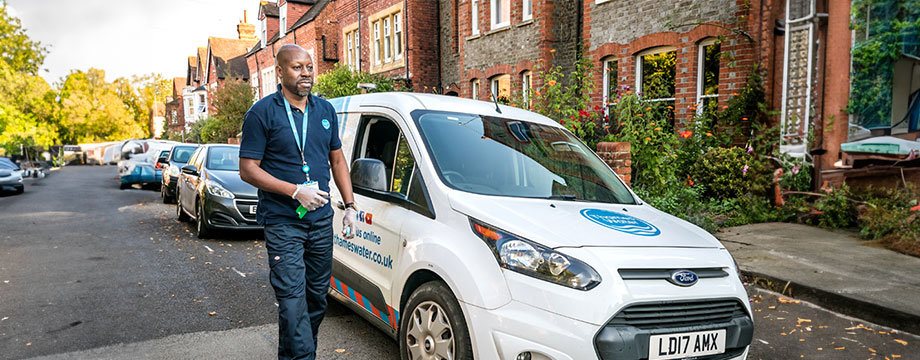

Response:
(636, 47), (677, 128)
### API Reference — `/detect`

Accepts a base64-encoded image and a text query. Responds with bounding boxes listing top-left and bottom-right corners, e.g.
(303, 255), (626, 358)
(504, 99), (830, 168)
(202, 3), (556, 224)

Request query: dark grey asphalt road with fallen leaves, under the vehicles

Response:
(0, 166), (920, 360)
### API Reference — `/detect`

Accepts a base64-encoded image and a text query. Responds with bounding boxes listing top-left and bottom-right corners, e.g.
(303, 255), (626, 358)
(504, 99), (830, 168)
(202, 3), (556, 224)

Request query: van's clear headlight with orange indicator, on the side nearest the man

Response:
(470, 218), (601, 291)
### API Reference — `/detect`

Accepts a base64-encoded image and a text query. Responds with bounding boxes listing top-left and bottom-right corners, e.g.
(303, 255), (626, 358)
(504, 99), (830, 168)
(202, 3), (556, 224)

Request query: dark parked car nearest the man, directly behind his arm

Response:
(176, 144), (262, 238)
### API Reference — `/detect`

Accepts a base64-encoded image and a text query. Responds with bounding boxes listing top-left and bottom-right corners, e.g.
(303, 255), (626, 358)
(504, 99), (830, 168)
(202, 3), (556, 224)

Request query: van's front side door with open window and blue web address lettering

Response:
(332, 109), (415, 329)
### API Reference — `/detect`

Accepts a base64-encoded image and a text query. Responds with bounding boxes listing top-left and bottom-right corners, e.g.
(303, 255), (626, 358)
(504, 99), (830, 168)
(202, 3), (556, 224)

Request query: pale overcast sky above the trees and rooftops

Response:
(9, 0), (260, 85)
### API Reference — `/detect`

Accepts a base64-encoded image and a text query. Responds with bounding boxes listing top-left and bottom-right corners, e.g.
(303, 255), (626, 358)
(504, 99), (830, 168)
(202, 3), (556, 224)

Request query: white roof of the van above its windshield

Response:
(329, 92), (561, 126)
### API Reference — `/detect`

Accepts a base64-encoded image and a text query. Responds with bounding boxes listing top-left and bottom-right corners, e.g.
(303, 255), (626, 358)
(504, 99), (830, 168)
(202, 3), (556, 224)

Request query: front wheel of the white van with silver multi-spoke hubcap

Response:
(399, 281), (473, 360)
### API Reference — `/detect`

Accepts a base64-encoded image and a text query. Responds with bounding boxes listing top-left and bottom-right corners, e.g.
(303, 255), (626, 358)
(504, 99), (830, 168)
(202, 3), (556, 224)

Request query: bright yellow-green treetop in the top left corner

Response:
(0, 0), (48, 75)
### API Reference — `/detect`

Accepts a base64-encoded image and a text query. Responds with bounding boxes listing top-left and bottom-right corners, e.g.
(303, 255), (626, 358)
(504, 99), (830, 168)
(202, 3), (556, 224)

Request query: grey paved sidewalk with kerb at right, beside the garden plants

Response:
(715, 223), (920, 334)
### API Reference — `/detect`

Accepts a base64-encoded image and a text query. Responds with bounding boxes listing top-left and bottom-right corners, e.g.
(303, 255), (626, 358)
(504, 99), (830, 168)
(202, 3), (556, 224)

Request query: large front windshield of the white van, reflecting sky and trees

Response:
(412, 111), (635, 204)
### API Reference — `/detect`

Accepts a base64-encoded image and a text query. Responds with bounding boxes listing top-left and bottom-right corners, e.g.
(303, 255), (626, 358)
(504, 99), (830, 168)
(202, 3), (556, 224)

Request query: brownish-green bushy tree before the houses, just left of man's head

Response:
(190, 78), (253, 143)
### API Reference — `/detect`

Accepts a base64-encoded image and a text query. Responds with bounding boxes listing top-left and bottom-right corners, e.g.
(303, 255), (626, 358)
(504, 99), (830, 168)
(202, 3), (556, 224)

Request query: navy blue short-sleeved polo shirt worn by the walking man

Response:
(240, 85), (342, 225)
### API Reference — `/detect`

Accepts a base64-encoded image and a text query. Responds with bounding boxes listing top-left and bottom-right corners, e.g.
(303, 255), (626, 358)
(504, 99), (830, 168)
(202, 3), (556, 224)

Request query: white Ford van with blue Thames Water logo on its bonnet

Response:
(330, 93), (753, 360)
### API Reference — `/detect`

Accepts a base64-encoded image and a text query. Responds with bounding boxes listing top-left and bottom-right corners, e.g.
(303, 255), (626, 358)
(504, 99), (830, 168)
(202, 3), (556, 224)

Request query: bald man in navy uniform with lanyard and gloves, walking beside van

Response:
(240, 44), (356, 360)
